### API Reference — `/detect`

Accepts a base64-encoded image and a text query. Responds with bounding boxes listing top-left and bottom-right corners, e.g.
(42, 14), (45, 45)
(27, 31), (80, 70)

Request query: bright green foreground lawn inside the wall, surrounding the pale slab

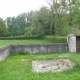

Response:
(0, 52), (80, 80)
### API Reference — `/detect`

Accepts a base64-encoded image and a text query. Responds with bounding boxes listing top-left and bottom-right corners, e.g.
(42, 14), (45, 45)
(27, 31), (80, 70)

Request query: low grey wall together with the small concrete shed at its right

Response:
(0, 34), (80, 60)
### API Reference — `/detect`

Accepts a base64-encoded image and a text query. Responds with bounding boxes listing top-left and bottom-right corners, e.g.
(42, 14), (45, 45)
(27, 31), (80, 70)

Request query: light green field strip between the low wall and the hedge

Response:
(0, 39), (52, 46)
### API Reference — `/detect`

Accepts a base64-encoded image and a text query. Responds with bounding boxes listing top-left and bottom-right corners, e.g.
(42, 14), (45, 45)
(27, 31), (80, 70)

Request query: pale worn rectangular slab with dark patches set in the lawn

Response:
(32, 59), (74, 72)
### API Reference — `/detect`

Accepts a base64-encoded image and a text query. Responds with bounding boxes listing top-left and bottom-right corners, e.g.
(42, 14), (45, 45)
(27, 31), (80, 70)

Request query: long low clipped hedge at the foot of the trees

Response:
(0, 36), (67, 43)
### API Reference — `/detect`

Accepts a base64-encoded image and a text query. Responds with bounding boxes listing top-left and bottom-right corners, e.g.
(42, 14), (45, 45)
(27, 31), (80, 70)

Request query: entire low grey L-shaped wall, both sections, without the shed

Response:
(0, 43), (67, 61)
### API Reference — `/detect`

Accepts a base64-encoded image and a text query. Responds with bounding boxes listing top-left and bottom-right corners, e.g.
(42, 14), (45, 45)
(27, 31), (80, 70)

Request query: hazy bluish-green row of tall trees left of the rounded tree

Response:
(5, 11), (33, 36)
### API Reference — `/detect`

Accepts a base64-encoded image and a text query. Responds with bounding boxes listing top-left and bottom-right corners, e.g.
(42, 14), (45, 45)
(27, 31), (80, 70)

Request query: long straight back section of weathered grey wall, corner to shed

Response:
(11, 43), (67, 53)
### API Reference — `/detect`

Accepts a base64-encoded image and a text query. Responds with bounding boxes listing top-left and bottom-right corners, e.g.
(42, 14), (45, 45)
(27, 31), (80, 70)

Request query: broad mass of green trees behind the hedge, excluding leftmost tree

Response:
(0, 0), (80, 36)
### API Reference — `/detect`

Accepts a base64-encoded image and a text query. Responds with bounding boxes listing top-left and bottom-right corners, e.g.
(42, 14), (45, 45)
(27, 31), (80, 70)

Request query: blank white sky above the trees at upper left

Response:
(0, 0), (48, 19)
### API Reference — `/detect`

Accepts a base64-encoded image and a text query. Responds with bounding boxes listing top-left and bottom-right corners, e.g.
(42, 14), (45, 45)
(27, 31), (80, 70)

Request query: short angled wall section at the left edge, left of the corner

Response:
(0, 45), (10, 61)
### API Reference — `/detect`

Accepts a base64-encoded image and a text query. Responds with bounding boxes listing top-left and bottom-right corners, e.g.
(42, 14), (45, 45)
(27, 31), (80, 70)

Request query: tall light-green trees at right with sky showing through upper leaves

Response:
(47, 0), (80, 35)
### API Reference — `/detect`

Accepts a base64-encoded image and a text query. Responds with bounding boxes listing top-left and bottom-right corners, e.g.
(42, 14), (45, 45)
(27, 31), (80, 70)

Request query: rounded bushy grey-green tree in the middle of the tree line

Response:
(32, 6), (51, 35)
